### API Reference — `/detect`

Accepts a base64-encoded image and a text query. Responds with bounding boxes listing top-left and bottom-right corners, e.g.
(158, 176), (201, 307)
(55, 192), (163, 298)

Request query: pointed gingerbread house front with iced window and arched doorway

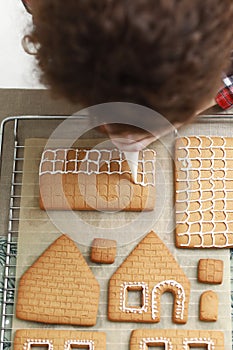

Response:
(108, 231), (190, 323)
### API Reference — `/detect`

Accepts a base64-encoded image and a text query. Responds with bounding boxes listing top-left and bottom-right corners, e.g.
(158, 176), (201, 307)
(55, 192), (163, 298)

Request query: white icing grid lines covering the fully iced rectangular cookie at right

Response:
(176, 136), (233, 248)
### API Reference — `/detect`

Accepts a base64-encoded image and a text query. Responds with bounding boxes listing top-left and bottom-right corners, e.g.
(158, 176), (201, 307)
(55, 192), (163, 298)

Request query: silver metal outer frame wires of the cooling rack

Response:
(0, 115), (233, 350)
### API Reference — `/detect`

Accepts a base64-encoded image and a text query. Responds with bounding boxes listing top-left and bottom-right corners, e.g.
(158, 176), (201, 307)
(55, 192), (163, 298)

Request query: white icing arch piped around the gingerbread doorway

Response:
(152, 280), (185, 320)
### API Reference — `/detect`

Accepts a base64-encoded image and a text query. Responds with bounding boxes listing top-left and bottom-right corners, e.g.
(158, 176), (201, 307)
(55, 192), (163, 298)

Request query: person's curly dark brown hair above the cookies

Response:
(27, 0), (233, 120)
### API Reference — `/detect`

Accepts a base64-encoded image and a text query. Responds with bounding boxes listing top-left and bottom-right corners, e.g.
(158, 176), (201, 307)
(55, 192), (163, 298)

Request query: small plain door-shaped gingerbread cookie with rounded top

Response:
(199, 290), (218, 322)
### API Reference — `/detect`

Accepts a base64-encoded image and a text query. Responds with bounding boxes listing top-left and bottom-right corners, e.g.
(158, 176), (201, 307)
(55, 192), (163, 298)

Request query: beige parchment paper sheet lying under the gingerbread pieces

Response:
(13, 125), (231, 350)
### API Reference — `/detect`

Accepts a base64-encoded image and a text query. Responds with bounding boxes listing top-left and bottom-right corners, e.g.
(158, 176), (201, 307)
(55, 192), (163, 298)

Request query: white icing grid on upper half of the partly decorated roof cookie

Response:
(39, 149), (155, 186)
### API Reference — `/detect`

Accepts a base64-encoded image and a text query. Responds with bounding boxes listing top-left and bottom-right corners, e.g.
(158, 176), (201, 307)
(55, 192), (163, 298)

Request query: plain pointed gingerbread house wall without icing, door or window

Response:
(16, 235), (100, 326)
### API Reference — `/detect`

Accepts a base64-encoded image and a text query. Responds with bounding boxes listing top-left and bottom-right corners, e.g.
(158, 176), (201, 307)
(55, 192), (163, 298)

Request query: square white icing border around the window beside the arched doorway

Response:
(120, 282), (149, 314)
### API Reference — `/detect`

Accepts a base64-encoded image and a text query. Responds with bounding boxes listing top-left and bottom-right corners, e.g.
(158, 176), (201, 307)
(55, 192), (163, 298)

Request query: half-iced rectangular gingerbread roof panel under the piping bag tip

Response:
(39, 149), (155, 211)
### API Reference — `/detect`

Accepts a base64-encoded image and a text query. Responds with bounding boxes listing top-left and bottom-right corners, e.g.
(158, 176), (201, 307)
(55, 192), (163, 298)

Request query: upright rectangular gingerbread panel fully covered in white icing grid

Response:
(175, 136), (233, 248)
